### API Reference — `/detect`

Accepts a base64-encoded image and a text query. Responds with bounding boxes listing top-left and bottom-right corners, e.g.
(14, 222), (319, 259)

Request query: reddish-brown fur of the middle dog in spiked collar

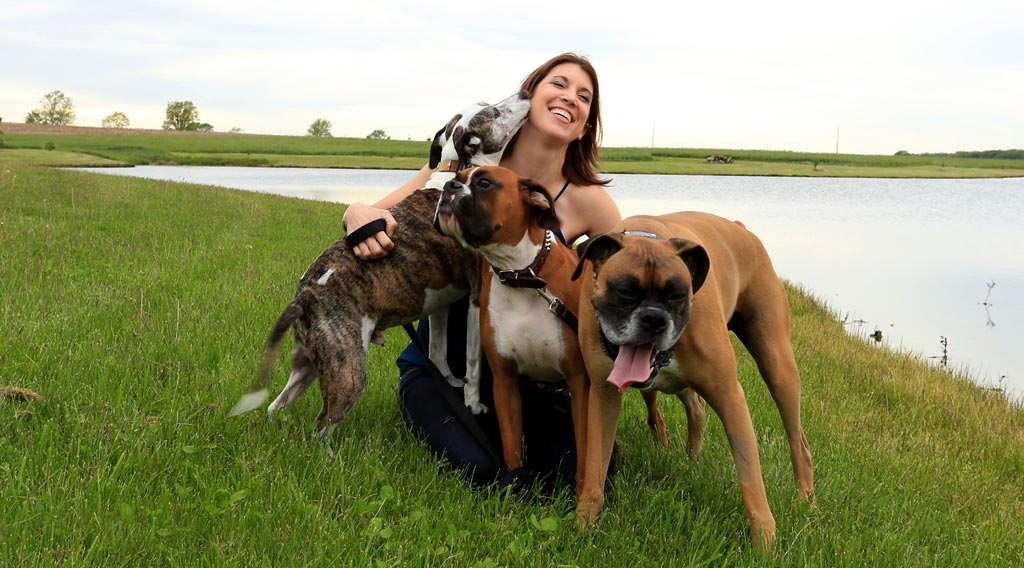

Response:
(436, 167), (668, 494)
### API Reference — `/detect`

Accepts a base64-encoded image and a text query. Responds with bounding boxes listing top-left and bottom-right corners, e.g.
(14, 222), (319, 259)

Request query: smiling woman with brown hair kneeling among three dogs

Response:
(329, 53), (621, 497)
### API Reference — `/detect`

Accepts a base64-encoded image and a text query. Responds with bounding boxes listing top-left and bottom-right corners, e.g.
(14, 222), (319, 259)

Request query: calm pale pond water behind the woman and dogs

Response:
(79, 166), (1024, 400)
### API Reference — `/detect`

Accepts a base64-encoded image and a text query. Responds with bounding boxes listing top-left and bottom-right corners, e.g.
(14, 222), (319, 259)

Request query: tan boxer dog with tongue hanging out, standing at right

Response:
(573, 212), (814, 548)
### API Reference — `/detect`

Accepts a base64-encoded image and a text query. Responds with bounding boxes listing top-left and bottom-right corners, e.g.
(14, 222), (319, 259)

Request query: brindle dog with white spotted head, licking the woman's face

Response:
(231, 92), (529, 452)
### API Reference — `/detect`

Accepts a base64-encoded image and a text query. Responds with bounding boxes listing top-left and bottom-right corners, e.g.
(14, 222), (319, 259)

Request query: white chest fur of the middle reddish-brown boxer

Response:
(487, 278), (565, 383)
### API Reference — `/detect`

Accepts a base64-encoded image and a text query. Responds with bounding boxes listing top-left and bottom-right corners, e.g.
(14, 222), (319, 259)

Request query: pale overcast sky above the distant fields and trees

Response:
(0, 0), (1024, 154)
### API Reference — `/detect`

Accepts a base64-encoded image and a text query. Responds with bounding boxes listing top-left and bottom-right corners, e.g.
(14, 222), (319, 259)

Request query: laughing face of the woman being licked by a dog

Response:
(529, 63), (594, 143)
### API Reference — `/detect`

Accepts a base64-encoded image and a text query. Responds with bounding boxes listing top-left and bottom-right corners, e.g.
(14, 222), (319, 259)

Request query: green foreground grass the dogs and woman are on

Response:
(6, 162), (1024, 567)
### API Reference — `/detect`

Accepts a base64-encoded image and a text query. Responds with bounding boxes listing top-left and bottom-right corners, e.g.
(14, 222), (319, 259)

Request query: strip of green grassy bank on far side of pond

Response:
(6, 125), (1024, 178)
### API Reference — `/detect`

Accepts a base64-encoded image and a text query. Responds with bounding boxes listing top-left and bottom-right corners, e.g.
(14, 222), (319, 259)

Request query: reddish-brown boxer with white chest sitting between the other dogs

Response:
(435, 167), (667, 493)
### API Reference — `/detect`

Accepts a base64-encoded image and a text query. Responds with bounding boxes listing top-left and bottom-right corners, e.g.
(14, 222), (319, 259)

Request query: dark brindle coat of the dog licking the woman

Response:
(261, 188), (480, 439)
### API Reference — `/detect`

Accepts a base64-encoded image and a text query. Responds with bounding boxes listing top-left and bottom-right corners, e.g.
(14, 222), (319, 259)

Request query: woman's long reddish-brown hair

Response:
(505, 52), (611, 185)
